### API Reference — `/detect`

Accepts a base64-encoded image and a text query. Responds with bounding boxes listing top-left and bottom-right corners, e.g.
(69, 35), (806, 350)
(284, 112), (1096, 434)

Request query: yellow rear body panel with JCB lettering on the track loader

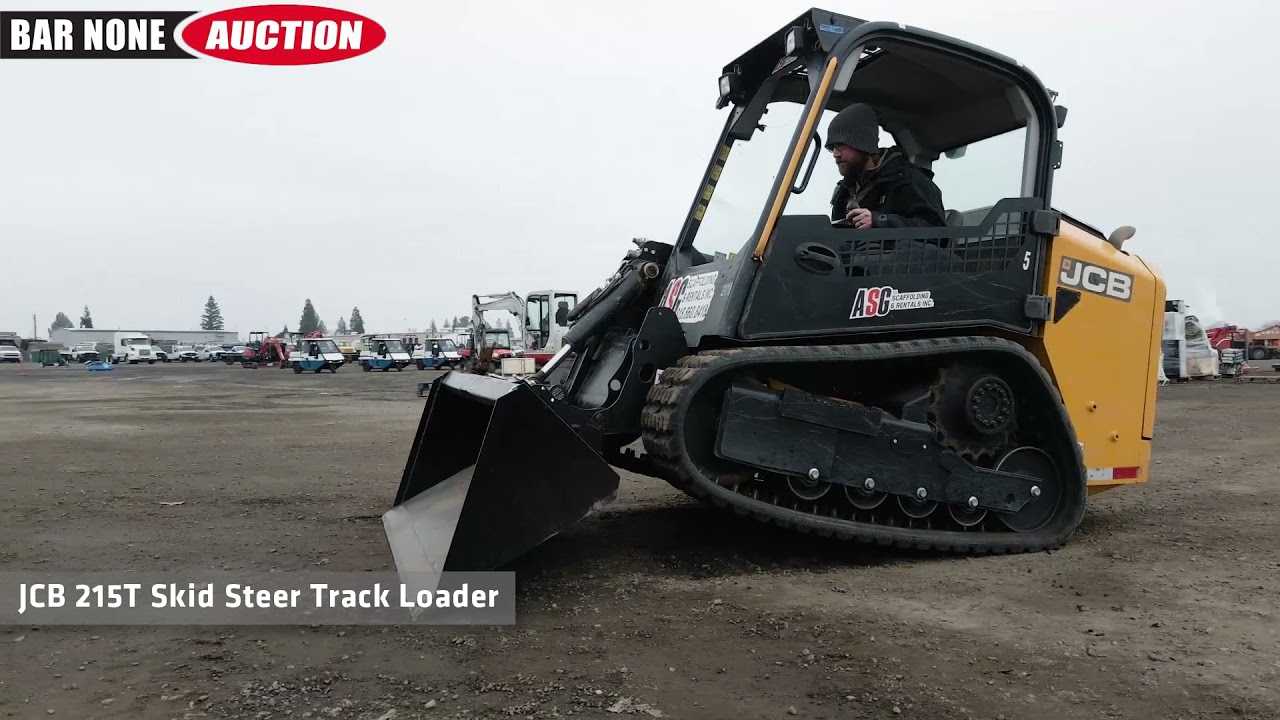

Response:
(1032, 217), (1165, 493)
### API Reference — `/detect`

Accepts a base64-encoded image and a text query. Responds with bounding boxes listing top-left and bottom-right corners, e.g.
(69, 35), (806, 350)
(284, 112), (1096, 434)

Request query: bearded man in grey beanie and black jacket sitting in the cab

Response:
(827, 102), (947, 228)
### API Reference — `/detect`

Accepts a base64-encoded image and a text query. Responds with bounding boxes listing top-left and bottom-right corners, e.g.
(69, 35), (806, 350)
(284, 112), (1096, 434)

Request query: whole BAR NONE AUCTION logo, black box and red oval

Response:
(0, 5), (387, 65)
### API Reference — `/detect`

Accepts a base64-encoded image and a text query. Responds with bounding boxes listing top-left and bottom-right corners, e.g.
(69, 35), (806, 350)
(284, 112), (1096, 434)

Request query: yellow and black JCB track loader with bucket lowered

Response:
(384, 9), (1165, 573)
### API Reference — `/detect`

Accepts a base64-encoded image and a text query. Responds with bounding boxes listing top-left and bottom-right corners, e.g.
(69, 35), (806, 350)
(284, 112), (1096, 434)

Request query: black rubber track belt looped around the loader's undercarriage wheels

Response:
(641, 337), (1088, 555)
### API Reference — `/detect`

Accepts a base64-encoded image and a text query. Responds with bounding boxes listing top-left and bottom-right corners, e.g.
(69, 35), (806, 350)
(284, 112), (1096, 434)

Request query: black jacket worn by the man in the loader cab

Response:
(831, 147), (947, 228)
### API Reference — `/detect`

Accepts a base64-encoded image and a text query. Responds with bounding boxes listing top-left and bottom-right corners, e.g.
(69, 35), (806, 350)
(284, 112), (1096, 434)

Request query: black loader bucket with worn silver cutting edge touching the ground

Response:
(383, 373), (618, 577)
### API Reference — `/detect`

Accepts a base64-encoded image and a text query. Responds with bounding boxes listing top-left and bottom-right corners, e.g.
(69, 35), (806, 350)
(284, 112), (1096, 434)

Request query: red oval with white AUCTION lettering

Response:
(182, 5), (387, 65)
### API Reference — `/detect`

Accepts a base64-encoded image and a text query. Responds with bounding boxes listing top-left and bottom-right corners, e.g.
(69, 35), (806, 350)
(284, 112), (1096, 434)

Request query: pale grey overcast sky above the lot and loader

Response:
(0, 0), (1280, 336)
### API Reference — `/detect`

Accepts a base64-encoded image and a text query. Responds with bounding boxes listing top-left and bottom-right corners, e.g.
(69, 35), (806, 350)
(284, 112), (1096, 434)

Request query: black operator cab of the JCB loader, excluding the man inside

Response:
(680, 9), (1066, 343)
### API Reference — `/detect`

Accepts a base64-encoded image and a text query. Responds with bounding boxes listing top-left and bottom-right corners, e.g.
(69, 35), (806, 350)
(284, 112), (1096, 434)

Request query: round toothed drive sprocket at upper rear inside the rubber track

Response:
(929, 364), (1018, 462)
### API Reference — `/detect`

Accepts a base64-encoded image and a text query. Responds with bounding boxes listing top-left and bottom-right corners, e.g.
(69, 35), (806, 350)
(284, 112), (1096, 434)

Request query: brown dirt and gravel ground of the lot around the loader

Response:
(0, 364), (1280, 720)
